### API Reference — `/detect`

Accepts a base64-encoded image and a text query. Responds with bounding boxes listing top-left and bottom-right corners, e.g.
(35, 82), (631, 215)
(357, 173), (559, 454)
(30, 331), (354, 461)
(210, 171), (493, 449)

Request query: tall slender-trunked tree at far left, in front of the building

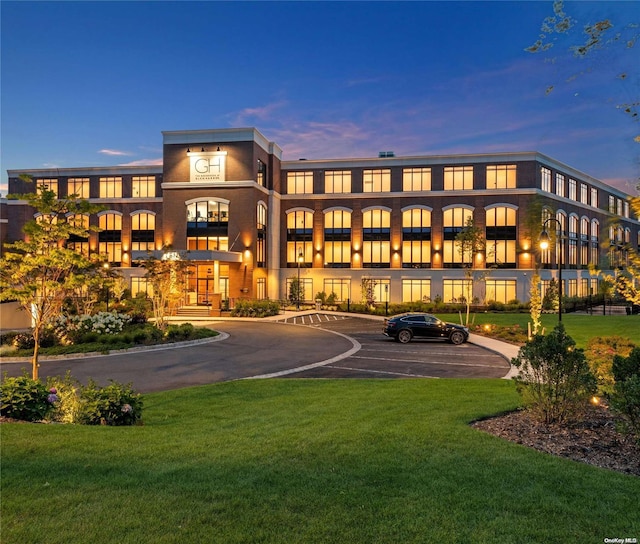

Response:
(0, 186), (100, 380)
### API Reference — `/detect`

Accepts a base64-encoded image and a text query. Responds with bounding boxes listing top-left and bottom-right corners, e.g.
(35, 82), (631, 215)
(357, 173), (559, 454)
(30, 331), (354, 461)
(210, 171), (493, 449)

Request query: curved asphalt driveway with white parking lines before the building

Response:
(2, 314), (509, 393)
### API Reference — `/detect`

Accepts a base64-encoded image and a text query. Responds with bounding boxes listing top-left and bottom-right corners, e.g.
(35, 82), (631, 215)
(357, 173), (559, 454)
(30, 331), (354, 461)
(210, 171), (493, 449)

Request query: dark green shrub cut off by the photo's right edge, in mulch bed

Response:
(611, 347), (640, 442)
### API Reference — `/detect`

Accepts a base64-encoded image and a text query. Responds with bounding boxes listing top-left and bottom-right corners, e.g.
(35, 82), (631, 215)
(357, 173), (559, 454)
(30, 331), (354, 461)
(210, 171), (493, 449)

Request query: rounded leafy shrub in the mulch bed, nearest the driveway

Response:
(511, 323), (596, 424)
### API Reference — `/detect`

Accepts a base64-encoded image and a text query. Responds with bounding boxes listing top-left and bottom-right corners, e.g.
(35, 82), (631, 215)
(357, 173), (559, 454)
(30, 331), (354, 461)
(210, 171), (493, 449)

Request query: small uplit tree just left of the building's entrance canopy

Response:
(144, 248), (189, 331)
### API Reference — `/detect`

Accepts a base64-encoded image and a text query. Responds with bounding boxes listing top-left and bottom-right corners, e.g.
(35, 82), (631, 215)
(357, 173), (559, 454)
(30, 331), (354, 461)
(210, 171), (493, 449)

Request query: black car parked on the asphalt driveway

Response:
(382, 313), (469, 344)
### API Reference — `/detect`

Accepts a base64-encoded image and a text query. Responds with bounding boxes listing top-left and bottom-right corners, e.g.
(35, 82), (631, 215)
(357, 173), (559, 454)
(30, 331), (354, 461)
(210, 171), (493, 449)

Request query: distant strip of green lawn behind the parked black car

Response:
(438, 313), (640, 348)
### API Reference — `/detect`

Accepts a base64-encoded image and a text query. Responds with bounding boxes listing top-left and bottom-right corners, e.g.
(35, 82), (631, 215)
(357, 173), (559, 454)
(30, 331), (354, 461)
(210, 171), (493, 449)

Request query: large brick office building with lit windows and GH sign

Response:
(2, 128), (640, 308)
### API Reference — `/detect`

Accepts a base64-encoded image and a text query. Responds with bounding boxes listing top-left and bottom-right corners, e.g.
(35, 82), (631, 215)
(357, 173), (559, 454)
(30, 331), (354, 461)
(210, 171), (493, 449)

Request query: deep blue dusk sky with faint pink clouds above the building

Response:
(0, 0), (640, 194)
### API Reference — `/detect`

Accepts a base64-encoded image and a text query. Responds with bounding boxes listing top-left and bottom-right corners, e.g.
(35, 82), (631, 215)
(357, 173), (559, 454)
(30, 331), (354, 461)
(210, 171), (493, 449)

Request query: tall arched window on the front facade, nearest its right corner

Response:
(485, 206), (516, 268)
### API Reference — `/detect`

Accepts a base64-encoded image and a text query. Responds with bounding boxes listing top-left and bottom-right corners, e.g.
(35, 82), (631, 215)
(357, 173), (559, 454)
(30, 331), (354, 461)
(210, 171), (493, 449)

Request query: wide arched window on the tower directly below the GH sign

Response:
(187, 199), (229, 251)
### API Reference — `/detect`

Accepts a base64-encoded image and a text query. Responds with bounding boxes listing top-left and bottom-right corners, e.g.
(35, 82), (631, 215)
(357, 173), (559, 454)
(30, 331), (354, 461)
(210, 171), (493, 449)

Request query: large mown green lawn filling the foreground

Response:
(0, 380), (640, 544)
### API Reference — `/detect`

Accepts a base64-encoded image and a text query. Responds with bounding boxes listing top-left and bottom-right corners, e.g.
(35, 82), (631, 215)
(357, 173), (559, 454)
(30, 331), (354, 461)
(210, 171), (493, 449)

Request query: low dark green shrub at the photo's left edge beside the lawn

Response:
(0, 374), (59, 421)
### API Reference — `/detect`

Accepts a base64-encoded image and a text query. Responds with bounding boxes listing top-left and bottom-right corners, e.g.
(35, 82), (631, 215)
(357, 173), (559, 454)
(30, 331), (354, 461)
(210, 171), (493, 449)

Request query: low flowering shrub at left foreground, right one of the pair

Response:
(78, 380), (142, 425)
